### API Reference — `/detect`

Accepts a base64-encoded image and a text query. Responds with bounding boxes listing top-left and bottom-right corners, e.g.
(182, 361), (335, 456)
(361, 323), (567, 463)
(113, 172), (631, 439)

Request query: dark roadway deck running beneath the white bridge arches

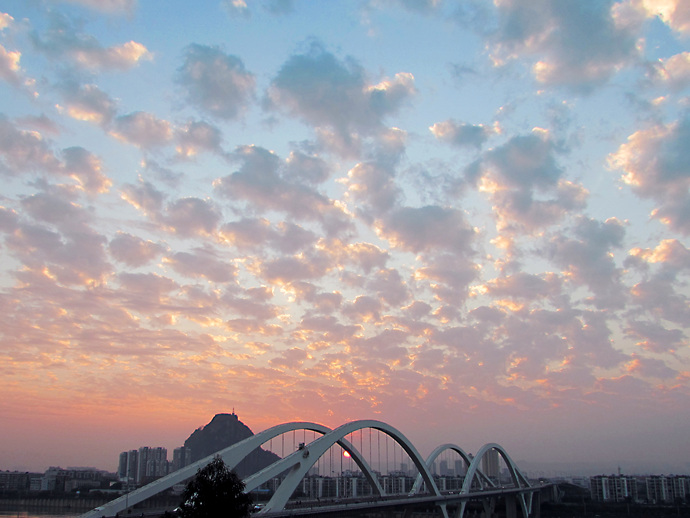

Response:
(255, 484), (551, 518)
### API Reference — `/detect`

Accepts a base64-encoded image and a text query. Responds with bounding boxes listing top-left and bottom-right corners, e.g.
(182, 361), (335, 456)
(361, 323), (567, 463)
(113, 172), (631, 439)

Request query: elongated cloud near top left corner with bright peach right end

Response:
(32, 13), (153, 71)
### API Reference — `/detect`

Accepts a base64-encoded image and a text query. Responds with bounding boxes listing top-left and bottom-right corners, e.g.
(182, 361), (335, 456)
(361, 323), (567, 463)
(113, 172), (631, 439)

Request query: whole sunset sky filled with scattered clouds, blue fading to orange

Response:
(0, 0), (690, 480)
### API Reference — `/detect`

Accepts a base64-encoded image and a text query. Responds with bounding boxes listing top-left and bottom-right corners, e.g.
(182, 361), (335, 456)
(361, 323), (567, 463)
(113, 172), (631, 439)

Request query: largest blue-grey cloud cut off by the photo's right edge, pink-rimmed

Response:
(608, 116), (690, 234)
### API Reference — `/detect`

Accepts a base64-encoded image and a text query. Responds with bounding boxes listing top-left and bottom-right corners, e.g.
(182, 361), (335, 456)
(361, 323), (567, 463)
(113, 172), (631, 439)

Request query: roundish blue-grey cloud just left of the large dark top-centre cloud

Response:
(177, 44), (256, 120)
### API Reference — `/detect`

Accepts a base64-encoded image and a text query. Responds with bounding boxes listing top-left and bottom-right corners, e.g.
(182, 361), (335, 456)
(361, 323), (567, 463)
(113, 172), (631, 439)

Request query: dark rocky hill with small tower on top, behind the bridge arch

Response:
(184, 413), (280, 477)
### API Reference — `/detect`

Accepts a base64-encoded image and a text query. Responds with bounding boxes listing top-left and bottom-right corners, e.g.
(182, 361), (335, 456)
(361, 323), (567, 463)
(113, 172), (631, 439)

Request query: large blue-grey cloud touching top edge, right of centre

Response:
(491, 0), (640, 91)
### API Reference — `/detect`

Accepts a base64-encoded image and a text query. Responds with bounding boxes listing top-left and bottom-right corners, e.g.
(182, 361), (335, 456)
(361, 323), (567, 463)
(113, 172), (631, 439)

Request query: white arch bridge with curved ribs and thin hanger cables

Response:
(81, 420), (543, 518)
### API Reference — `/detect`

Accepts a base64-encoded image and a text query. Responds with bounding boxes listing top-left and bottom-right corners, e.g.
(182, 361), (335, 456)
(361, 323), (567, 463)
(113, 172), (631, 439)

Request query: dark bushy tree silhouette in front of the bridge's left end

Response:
(180, 457), (252, 518)
